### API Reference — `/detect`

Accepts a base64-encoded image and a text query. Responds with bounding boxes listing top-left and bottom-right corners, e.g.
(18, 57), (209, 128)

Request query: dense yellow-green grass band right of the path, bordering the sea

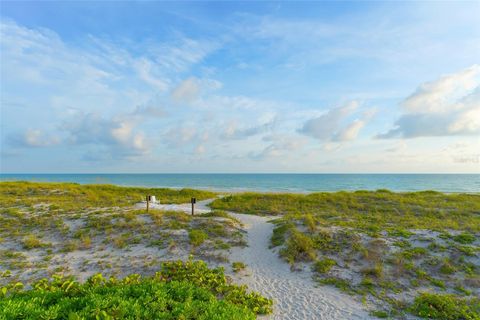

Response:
(211, 190), (480, 231)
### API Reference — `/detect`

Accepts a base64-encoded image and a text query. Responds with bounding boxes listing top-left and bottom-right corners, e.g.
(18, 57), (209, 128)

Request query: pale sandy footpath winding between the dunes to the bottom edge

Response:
(226, 213), (372, 320)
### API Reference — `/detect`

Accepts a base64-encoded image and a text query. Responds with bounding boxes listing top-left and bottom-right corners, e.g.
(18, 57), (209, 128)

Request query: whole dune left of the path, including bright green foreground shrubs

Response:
(0, 182), (272, 320)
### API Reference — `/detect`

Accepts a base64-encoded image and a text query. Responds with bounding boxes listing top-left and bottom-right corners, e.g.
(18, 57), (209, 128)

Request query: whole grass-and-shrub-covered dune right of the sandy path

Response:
(211, 190), (480, 319)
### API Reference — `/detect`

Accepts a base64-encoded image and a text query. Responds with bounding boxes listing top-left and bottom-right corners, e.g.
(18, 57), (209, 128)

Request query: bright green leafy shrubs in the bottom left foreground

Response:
(0, 261), (272, 319)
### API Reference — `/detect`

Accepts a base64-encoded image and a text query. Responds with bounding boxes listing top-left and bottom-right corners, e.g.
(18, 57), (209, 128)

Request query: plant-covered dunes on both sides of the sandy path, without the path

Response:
(0, 182), (480, 320)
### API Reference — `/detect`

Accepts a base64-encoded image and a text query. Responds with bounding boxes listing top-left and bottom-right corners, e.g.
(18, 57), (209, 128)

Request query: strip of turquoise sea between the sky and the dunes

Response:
(0, 174), (480, 192)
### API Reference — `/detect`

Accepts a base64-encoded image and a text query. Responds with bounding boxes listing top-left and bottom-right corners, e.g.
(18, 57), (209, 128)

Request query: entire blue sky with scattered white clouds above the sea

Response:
(0, 1), (480, 173)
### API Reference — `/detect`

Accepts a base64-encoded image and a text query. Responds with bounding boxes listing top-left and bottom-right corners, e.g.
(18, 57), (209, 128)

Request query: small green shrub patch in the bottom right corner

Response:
(410, 293), (480, 320)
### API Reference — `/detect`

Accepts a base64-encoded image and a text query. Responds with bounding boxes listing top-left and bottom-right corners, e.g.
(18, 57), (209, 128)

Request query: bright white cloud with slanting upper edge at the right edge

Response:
(377, 65), (480, 138)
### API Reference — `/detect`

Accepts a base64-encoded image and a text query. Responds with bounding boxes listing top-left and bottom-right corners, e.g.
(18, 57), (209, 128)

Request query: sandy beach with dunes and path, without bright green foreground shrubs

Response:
(0, 182), (480, 319)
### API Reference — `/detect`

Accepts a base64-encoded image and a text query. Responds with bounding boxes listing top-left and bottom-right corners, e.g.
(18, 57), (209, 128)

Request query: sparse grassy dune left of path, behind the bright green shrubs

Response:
(0, 182), (245, 286)
